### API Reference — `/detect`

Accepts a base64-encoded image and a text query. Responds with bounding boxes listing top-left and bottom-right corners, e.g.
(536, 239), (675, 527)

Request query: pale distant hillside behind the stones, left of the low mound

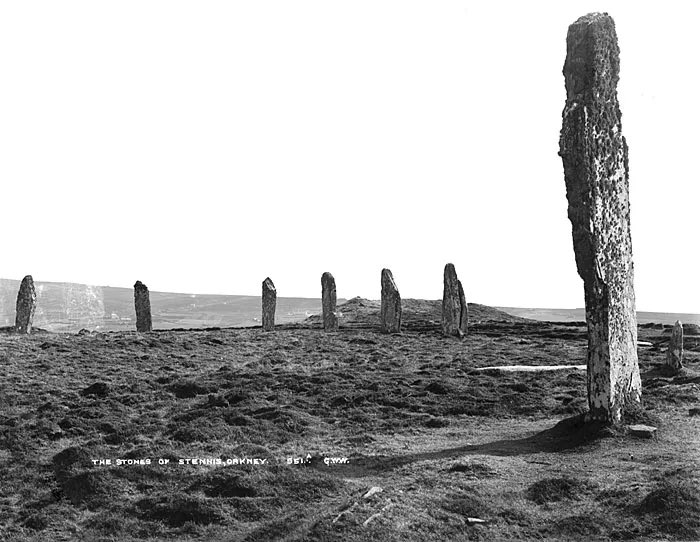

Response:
(0, 279), (336, 333)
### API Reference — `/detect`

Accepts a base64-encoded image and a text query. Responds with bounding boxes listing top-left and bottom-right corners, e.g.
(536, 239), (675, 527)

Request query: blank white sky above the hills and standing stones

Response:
(0, 0), (700, 312)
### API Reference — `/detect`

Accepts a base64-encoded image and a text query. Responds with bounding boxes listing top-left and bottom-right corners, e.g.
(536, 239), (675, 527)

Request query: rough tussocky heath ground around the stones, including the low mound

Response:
(0, 299), (700, 542)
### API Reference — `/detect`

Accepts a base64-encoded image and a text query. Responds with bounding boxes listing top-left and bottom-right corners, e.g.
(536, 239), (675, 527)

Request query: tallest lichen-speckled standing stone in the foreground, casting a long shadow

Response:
(559, 13), (642, 422)
